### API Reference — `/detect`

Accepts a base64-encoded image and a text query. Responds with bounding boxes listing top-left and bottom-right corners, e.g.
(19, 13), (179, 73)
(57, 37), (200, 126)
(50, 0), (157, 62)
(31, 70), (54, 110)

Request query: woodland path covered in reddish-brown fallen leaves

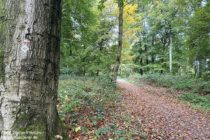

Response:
(118, 80), (210, 140)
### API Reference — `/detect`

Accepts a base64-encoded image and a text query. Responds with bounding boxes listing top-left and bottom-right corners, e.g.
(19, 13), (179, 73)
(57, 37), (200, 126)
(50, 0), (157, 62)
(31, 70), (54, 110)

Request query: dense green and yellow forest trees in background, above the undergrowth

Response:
(0, 0), (210, 79)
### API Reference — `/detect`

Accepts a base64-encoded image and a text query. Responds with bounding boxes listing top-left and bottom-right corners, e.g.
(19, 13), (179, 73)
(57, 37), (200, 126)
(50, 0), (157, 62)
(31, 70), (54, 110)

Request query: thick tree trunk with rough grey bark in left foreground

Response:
(0, 0), (61, 140)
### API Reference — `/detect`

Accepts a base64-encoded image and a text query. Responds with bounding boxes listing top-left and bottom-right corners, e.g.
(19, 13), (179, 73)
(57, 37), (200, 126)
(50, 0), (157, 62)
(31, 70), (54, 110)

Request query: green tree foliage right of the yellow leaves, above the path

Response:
(132, 0), (210, 76)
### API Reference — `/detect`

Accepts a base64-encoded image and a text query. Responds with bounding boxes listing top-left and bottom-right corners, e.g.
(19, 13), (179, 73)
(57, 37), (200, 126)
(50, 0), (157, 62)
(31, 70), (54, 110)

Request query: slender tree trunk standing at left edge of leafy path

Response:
(112, 0), (124, 82)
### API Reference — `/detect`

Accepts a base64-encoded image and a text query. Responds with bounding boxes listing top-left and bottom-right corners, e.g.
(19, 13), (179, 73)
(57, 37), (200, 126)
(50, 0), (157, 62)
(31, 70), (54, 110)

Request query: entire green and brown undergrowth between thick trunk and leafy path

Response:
(58, 77), (147, 140)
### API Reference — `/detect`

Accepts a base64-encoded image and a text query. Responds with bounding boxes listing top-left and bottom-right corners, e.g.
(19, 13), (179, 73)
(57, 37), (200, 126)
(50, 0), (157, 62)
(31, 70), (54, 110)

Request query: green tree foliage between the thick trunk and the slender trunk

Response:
(61, 0), (115, 75)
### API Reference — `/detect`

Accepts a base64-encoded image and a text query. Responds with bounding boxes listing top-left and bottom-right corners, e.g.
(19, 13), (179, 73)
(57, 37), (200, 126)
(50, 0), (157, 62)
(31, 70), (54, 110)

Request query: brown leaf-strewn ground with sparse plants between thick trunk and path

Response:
(64, 94), (147, 140)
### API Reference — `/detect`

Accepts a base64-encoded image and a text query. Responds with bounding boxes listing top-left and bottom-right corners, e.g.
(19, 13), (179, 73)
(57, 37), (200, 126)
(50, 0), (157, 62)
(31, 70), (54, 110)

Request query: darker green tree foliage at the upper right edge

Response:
(187, 2), (210, 60)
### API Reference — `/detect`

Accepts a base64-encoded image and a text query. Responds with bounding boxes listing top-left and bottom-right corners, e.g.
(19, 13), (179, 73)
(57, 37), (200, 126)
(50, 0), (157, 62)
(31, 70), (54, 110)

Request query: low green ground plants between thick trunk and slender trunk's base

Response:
(59, 77), (117, 113)
